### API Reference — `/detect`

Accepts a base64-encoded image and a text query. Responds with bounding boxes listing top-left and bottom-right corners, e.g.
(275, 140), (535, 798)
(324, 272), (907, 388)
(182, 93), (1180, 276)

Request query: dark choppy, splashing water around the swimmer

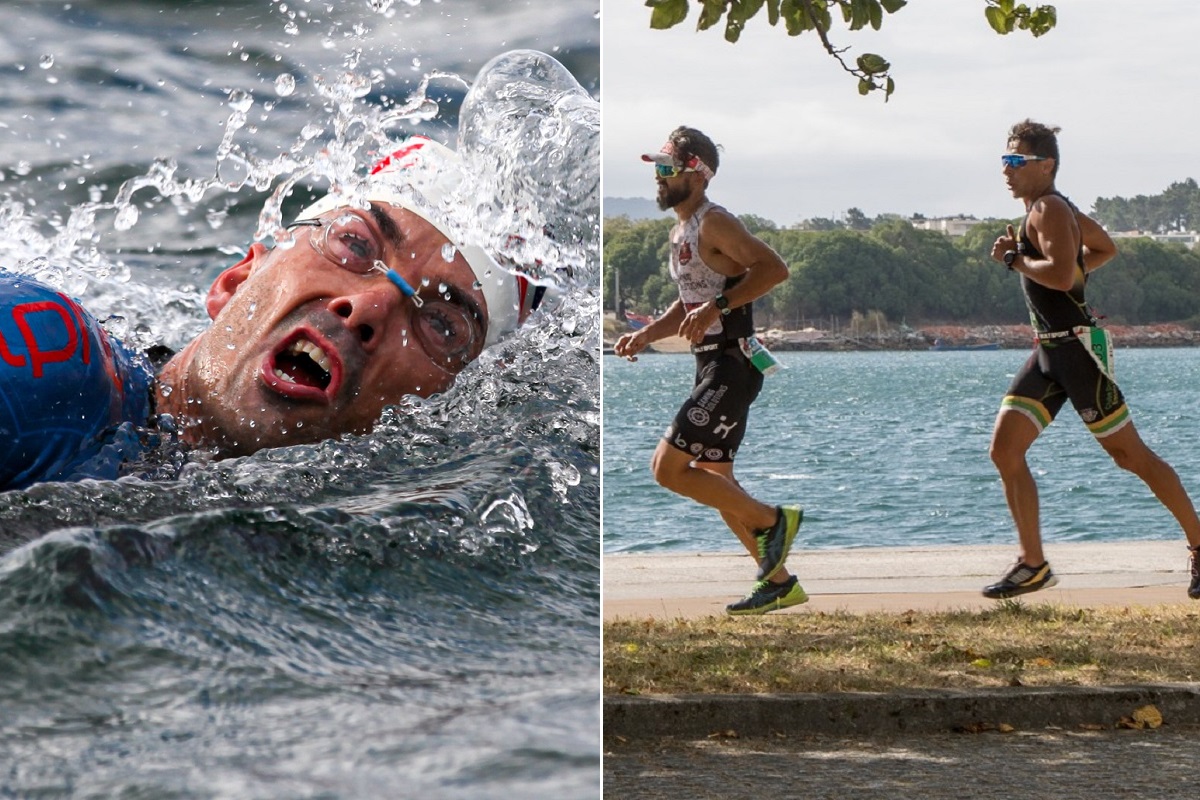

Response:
(0, 0), (600, 799)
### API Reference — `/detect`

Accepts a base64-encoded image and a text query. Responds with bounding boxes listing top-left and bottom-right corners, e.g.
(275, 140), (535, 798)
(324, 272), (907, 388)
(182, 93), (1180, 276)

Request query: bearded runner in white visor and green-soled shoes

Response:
(614, 127), (808, 614)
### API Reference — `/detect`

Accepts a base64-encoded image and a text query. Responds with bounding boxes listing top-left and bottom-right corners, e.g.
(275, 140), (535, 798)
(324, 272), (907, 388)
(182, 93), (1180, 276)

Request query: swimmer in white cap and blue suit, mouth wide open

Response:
(0, 54), (580, 489)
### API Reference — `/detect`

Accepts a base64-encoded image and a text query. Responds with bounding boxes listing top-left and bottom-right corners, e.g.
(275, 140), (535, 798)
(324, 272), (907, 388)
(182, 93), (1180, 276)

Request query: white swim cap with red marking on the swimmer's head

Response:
(298, 137), (546, 347)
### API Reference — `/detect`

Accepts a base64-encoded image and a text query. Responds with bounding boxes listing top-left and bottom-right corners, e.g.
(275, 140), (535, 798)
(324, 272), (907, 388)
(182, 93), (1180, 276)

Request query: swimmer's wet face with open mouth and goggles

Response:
(161, 203), (487, 455)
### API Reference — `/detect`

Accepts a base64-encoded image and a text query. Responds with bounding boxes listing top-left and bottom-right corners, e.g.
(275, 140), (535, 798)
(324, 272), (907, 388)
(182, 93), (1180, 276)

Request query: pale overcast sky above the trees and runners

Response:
(601, 0), (1200, 225)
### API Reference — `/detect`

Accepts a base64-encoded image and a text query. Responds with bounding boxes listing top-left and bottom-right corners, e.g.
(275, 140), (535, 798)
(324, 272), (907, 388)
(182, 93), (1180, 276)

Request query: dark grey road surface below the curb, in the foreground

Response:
(604, 727), (1200, 800)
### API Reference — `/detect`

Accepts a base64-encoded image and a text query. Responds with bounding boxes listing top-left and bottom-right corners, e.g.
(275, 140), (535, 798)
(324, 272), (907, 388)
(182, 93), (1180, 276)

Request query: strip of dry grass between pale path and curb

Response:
(604, 601), (1200, 694)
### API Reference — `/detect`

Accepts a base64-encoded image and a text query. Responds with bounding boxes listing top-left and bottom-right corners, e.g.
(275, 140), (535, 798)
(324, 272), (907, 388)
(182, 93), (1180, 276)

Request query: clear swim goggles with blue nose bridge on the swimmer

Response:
(287, 211), (482, 366)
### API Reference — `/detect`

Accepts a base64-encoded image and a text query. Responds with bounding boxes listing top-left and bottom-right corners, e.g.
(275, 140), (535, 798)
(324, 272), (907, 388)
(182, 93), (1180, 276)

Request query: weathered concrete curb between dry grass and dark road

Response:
(604, 684), (1200, 739)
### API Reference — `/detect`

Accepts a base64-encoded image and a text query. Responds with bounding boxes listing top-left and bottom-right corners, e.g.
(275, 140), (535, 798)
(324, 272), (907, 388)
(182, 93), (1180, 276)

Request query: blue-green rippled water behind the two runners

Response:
(604, 343), (1200, 553)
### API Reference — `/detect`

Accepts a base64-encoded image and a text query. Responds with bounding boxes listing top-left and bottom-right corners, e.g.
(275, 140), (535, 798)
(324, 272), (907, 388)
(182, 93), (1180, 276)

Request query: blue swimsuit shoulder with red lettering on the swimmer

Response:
(0, 271), (154, 491)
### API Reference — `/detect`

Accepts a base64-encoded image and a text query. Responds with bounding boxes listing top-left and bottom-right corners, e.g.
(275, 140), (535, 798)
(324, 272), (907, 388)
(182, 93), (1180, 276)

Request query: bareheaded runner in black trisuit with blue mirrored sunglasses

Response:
(983, 120), (1200, 599)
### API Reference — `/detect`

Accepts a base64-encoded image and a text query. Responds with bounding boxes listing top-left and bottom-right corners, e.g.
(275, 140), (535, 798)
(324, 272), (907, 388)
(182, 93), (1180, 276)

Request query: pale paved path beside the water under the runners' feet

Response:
(602, 536), (1200, 620)
